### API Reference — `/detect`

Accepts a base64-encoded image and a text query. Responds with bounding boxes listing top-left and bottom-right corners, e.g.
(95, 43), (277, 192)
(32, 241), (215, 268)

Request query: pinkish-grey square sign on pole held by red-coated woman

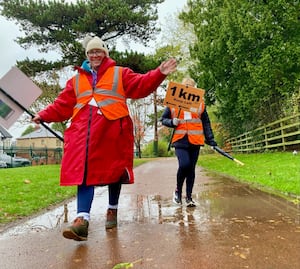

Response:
(0, 67), (42, 129)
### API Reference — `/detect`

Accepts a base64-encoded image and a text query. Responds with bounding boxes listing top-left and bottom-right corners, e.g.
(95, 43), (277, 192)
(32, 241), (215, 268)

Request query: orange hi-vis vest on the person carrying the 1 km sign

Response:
(171, 103), (205, 145)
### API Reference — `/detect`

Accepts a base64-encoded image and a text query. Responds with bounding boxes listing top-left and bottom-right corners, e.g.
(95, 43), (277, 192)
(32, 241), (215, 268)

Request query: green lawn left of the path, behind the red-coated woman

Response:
(0, 159), (150, 225)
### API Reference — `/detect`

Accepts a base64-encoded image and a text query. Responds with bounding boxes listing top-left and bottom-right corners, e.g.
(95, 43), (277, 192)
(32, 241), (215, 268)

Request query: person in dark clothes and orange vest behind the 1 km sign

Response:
(161, 78), (217, 207)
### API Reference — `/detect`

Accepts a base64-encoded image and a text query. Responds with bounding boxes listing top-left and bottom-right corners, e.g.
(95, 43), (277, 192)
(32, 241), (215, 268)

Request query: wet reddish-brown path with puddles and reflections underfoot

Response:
(0, 156), (300, 269)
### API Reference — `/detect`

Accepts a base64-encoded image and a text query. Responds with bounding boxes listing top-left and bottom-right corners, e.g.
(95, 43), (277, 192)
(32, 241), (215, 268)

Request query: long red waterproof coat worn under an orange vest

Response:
(38, 58), (166, 186)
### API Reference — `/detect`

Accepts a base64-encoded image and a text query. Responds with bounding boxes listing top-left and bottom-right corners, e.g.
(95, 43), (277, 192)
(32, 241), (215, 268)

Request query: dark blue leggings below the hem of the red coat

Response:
(77, 182), (121, 213)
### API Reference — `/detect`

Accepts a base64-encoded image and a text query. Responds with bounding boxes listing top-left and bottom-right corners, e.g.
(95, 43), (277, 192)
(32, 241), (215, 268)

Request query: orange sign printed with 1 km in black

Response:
(164, 82), (205, 112)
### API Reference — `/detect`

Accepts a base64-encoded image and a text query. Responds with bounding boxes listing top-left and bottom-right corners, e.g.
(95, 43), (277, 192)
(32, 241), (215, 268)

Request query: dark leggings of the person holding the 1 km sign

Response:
(175, 146), (200, 198)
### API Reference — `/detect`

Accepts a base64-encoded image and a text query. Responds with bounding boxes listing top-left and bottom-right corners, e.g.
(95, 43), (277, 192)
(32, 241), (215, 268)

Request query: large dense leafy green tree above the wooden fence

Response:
(180, 0), (300, 135)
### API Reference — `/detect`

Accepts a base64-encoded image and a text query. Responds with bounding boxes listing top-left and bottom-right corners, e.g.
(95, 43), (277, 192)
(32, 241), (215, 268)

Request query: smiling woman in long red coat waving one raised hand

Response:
(32, 36), (176, 241)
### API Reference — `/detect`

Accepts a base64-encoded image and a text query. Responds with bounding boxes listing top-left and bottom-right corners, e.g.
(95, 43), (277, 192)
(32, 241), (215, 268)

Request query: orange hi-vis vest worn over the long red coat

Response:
(72, 66), (129, 120)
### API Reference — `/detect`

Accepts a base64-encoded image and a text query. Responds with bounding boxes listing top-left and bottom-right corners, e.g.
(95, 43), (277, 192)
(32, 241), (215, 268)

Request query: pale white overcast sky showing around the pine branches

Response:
(0, 0), (187, 138)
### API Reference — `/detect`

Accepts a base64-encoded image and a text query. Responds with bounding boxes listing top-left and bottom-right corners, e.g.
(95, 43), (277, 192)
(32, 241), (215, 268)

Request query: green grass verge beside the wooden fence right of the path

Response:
(198, 152), (300, 197)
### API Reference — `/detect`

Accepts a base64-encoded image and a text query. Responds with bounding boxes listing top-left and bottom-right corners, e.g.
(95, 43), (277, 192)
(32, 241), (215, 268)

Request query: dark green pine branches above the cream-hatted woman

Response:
(0, 0), (163, 74)
